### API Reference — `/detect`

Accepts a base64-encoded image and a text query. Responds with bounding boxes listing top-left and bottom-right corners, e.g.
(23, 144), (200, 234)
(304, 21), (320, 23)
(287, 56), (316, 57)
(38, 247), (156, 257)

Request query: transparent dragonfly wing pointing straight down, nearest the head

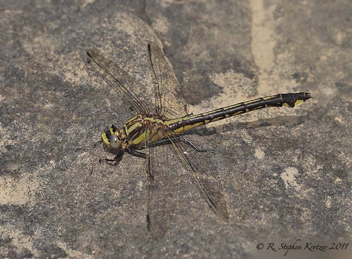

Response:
(145, 129), (178, 240)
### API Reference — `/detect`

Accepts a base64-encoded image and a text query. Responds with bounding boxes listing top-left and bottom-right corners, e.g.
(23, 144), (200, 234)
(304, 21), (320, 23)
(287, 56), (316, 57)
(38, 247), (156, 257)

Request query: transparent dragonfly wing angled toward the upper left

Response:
(86, 49), (154, 114)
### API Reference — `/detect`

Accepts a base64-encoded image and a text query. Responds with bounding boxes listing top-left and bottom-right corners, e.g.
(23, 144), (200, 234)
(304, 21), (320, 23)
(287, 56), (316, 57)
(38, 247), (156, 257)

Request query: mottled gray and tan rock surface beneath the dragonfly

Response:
(0, 0), (352, 258)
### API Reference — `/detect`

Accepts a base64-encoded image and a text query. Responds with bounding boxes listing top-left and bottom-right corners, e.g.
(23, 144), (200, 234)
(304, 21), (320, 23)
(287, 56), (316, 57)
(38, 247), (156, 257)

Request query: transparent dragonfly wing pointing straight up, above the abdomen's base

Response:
(148, 43), (186, 119)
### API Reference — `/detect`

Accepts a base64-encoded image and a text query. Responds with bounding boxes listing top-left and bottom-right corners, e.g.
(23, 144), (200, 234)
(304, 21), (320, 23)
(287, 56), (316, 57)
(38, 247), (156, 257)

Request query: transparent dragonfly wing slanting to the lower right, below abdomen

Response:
(166, 134), (229, 221)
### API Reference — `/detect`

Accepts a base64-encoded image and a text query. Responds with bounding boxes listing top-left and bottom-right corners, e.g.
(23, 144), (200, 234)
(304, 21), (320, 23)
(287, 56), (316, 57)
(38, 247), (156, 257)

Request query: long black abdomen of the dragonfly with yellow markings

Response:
(168, 92), (311, 133)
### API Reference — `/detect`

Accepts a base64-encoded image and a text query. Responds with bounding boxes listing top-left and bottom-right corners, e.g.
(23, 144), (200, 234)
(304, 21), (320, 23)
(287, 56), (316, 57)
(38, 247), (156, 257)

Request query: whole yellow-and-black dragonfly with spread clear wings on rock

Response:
(86, 42), (311, 239)
